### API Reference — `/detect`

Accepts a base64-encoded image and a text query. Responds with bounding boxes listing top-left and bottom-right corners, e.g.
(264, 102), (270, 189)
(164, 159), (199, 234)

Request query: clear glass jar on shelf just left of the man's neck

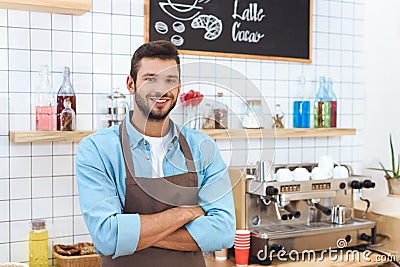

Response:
(107, 88), (128, 127)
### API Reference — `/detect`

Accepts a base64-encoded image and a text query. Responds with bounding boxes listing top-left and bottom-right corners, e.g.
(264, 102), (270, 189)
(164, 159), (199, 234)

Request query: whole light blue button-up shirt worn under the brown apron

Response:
(76, 113), (236, 258)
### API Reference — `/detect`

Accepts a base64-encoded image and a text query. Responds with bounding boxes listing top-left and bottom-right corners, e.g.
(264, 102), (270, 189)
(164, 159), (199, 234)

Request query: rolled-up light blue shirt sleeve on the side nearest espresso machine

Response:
(185, 141), (236, 251)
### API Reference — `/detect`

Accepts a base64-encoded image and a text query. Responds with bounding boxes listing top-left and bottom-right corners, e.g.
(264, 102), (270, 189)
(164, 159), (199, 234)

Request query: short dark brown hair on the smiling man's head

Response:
(130, 40), (181, 85)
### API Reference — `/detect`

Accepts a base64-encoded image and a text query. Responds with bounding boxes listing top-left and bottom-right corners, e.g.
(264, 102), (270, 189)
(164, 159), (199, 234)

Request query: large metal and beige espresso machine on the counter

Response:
(245, 164), (375, 265)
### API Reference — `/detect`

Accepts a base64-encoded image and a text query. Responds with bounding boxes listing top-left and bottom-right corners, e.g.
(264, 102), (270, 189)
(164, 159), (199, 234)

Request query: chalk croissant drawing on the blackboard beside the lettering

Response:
(191, 15), (223, 41)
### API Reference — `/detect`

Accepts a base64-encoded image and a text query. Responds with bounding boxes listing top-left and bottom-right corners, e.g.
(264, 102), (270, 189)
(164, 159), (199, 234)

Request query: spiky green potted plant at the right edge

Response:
(369, 135), (400, 195)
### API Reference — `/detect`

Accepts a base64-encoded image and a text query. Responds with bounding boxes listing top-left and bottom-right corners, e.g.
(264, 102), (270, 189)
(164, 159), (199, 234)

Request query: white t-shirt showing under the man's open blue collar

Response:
(143, 130), (172, 178)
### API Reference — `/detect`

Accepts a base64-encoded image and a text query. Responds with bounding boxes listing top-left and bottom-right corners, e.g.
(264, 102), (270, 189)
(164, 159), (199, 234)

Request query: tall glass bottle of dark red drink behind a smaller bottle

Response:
(57, 67), (76, 130)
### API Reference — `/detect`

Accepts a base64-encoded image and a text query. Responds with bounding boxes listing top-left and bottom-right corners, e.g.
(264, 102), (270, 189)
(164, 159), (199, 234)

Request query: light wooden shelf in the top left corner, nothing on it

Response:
(0, 0), (92, 16)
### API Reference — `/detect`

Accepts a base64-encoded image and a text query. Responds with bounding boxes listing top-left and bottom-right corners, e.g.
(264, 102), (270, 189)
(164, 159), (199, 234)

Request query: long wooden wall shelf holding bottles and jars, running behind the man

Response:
(10, 128), (356, 143)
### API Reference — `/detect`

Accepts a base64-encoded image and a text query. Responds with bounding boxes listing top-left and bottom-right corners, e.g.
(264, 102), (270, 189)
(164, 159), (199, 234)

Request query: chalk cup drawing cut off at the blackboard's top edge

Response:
(158, 0), (203, 21)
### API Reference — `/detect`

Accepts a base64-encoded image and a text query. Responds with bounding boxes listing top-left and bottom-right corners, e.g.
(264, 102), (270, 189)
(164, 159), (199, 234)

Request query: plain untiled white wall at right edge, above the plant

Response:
(363, 0), (400, 200)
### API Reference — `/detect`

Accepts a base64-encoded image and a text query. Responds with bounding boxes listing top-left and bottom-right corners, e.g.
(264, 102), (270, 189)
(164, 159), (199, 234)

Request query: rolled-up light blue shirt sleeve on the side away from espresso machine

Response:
(76, 138), (140, 258)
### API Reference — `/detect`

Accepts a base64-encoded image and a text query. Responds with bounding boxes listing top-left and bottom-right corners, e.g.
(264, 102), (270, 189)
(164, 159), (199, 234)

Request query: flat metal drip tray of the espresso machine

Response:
(249, 219), (375, 239)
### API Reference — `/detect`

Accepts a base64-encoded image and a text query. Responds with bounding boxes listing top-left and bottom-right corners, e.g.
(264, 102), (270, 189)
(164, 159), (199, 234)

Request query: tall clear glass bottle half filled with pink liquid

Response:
(35, 65), (56, 131)
